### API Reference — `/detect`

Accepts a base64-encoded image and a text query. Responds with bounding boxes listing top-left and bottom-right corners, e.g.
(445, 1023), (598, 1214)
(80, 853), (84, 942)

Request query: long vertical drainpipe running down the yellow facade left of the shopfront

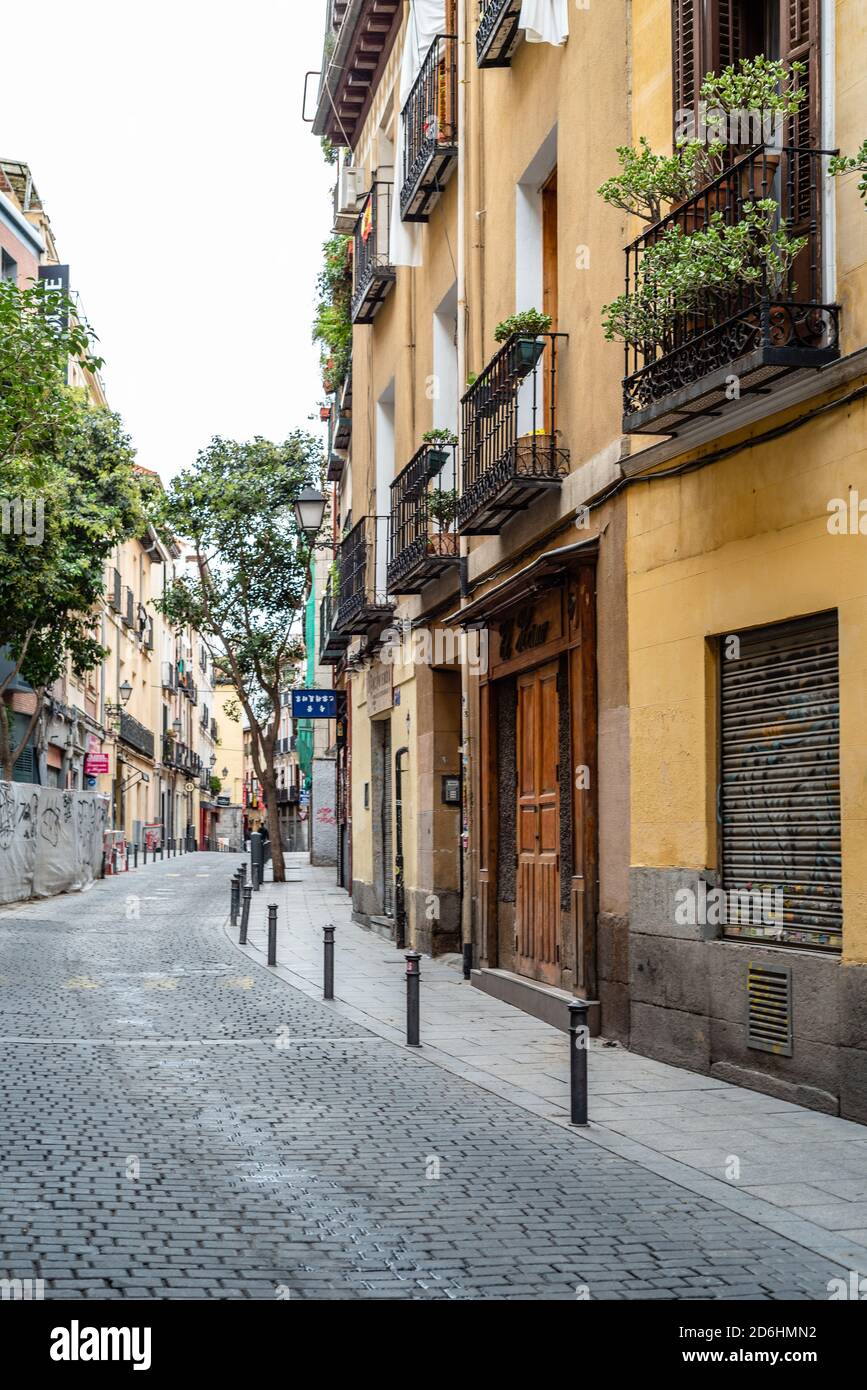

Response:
(457, 0), (472, 959)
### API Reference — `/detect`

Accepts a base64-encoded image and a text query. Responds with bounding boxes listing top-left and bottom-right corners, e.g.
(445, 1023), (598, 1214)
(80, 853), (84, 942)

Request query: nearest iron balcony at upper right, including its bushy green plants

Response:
(599, 60), (839, 435)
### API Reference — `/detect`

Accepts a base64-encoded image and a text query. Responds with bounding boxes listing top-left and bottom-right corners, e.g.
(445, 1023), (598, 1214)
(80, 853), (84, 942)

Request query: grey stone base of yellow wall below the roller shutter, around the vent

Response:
(629, 869), (867, 1123)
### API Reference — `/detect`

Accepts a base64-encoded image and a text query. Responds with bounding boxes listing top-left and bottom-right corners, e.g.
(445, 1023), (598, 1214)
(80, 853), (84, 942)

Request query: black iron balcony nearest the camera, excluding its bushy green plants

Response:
(622, 146), (839, 435)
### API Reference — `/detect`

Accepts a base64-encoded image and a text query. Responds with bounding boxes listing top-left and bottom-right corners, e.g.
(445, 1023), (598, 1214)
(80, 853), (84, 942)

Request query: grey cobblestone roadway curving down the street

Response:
(0, 855), (845, 1300)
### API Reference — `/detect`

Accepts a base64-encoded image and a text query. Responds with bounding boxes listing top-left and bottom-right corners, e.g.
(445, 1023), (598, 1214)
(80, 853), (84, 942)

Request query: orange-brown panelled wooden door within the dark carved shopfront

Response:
(515, 662), (560, 984)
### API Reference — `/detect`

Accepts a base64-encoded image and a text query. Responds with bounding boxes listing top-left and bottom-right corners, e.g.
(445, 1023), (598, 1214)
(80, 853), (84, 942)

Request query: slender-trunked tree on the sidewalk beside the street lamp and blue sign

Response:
(157, 431), (324, 883)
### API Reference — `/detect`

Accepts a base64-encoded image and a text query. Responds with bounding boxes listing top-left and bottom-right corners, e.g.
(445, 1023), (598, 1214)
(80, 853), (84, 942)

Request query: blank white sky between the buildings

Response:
(0, 0), (333, 478)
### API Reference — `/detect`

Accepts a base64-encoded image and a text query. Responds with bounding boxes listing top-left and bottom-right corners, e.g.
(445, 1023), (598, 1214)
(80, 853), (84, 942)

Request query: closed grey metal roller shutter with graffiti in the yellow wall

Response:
(720, 613), (842, 951)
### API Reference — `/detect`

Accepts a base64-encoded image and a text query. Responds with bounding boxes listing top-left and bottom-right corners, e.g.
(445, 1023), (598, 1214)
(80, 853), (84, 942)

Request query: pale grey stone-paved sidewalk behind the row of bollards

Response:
(234, 855), (867, 1273)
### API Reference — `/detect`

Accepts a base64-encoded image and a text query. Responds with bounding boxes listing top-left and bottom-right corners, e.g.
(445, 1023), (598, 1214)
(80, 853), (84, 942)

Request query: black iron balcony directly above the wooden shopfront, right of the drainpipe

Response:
(457, 334), (568, 535)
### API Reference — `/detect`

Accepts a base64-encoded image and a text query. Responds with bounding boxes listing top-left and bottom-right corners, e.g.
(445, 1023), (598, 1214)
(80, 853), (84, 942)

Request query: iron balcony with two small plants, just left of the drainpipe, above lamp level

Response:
(388, 443), (460, 594)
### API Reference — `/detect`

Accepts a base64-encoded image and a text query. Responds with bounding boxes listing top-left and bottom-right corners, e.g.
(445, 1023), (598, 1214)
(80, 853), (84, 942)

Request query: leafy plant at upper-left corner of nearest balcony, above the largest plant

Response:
(599, 135), (725, 224)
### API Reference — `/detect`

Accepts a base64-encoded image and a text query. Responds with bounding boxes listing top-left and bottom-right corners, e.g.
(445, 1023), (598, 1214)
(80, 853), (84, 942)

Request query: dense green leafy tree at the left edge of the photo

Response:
(0, 281), (146, 781)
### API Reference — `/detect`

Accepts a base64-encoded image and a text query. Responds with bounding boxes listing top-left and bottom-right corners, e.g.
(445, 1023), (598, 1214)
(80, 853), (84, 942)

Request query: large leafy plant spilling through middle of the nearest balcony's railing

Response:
(603, 199), (807, 342)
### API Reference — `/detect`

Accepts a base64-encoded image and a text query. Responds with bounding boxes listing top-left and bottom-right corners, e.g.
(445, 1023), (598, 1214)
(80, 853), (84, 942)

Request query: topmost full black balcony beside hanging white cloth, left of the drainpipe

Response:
(400, 33), (457, 222)
